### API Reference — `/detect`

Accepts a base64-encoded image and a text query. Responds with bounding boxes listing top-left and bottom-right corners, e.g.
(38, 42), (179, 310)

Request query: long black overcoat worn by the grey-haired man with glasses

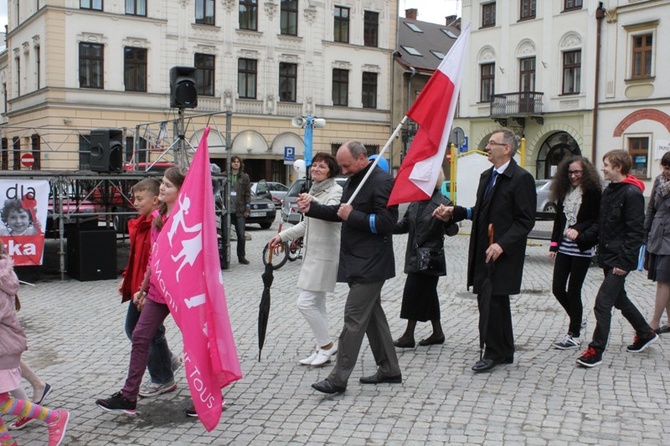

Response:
(454, 159), (537, 295)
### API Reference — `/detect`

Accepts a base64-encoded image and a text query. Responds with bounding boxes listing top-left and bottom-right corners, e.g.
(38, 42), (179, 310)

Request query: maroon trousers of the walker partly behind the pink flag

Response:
(121, 299), (172, 401)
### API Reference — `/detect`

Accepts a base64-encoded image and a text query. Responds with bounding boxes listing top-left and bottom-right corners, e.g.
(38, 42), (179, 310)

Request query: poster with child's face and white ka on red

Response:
(0, 179), (49, 266)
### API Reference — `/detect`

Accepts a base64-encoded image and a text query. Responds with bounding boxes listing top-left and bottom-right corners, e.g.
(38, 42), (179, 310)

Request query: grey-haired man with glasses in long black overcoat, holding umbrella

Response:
(434, 129), (537, 373)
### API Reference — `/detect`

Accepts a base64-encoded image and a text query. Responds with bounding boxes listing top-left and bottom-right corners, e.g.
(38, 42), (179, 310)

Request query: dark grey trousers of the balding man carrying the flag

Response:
(328, 280), (400, 387)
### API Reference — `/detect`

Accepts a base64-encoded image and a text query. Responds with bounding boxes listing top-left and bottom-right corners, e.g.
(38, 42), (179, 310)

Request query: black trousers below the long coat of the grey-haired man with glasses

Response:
(479, 295), (514, 363)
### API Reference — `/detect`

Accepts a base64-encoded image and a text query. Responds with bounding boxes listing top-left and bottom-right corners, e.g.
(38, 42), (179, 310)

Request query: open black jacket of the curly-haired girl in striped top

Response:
(549, 184), (602, 251)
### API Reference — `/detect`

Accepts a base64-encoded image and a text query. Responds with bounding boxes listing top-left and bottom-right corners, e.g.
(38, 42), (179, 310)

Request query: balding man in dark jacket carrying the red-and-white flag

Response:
(297, 141), (402, 393)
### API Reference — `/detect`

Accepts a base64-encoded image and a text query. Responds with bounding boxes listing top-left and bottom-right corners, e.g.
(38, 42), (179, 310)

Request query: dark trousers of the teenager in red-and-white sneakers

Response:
(589, 269), (651, 354)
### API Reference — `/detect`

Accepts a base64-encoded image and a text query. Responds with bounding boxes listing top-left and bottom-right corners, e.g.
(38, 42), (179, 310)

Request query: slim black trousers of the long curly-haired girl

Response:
(552, 252), (591, 338)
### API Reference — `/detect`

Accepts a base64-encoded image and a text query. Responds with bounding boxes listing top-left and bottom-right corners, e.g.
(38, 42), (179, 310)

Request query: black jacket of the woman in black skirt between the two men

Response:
(393, 189), (458, 276)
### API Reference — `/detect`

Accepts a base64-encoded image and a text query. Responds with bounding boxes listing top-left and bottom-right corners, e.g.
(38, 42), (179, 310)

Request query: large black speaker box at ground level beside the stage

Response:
(67, 227), (118, 282)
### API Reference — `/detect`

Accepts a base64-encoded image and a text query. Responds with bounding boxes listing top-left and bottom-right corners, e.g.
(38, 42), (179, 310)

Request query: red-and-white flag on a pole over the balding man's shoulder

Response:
(388, 25), (470, 206)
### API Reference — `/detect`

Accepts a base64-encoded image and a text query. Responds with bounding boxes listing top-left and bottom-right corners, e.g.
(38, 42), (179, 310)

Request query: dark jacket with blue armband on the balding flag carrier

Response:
(306, 163), (398, 283)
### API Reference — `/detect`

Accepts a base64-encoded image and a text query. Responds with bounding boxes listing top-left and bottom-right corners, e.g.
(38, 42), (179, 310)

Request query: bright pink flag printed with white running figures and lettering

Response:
(151, 127), (242, 431)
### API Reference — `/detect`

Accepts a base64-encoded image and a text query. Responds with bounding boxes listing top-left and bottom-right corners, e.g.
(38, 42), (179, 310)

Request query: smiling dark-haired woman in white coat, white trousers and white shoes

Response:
(268, 152), (342, 367)
